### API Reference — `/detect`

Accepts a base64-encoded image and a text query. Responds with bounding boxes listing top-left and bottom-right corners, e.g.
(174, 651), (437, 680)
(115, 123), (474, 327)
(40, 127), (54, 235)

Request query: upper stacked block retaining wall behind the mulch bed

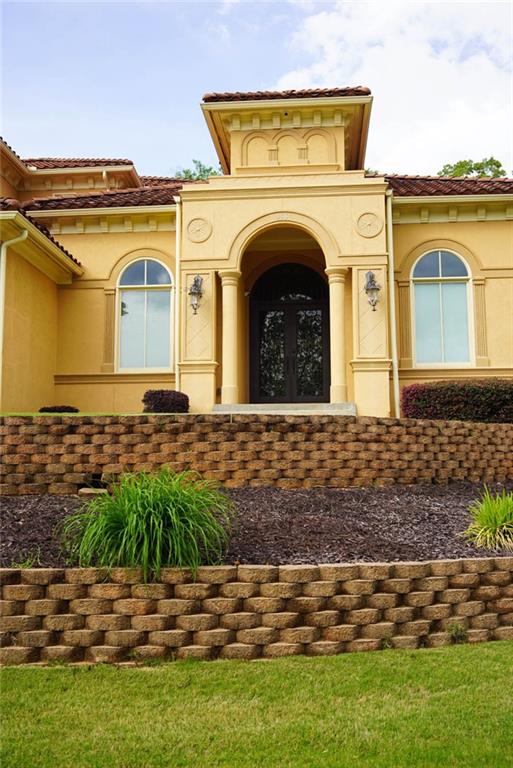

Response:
(0, 414), (513, 494)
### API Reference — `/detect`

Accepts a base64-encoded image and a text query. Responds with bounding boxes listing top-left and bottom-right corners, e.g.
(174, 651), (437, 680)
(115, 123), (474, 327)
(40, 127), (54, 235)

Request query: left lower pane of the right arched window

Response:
(415, 283), (443, 363)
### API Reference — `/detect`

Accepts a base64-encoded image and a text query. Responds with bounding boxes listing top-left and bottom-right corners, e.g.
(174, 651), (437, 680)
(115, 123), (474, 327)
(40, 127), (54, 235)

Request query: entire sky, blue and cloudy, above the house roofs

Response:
(2, 0), (513, 174)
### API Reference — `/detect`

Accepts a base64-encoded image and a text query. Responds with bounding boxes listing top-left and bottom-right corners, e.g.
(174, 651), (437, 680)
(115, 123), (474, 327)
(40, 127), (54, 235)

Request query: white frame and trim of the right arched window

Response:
(410, 248), (476, 369)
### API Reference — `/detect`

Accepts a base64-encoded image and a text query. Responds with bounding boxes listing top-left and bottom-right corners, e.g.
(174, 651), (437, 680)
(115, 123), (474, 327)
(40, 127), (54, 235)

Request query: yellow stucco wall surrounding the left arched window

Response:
(48, 231), (175, 412)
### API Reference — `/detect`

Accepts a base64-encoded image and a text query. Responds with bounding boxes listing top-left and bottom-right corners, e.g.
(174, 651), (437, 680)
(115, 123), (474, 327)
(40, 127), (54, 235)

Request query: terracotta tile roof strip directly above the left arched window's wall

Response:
(23, 180), (183, 211)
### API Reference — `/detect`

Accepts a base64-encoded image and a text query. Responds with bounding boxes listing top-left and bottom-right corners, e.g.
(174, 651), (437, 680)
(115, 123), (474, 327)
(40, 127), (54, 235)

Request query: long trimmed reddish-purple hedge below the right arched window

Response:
(401, 379), (513, 424)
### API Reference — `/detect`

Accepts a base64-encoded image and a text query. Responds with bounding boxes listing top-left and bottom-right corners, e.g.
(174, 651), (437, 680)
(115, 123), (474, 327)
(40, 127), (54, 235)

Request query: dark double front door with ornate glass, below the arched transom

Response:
(251, 300), (329, 403)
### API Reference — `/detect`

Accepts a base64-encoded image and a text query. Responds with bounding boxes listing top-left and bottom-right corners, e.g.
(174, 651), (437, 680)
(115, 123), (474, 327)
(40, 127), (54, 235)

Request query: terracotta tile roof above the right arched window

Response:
(382, 174), (513, 197)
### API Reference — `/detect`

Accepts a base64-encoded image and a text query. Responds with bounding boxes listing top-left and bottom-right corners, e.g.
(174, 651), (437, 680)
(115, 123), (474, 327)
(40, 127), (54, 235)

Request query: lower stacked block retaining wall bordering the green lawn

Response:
(0, 557), (513, 664)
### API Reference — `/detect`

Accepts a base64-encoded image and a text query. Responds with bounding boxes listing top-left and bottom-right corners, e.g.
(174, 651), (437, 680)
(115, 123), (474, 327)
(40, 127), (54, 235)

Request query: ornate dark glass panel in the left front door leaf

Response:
(258, 310), (287, 398)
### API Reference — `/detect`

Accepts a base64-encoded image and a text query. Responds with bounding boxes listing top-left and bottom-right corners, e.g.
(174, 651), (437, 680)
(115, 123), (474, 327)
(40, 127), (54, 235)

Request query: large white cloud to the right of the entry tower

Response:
(277, 0), (513, 173)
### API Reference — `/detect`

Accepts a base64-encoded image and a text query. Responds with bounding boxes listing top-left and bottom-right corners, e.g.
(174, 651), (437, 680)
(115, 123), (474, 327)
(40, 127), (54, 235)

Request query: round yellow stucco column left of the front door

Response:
(219, 270), (241, 404)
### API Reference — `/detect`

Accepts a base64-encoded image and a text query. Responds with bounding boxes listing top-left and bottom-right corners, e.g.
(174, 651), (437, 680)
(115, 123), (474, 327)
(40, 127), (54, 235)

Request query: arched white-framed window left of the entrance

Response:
(118, 259), (172, 370)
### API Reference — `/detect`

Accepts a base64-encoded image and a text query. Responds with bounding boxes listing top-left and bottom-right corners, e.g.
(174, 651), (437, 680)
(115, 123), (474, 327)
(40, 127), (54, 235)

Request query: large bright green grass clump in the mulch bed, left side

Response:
(61, 469), (233, 581)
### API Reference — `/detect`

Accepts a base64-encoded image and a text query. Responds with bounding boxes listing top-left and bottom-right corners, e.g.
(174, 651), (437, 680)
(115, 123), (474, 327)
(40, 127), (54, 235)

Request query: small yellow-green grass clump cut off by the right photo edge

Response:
(465, 488), (513, 549)
